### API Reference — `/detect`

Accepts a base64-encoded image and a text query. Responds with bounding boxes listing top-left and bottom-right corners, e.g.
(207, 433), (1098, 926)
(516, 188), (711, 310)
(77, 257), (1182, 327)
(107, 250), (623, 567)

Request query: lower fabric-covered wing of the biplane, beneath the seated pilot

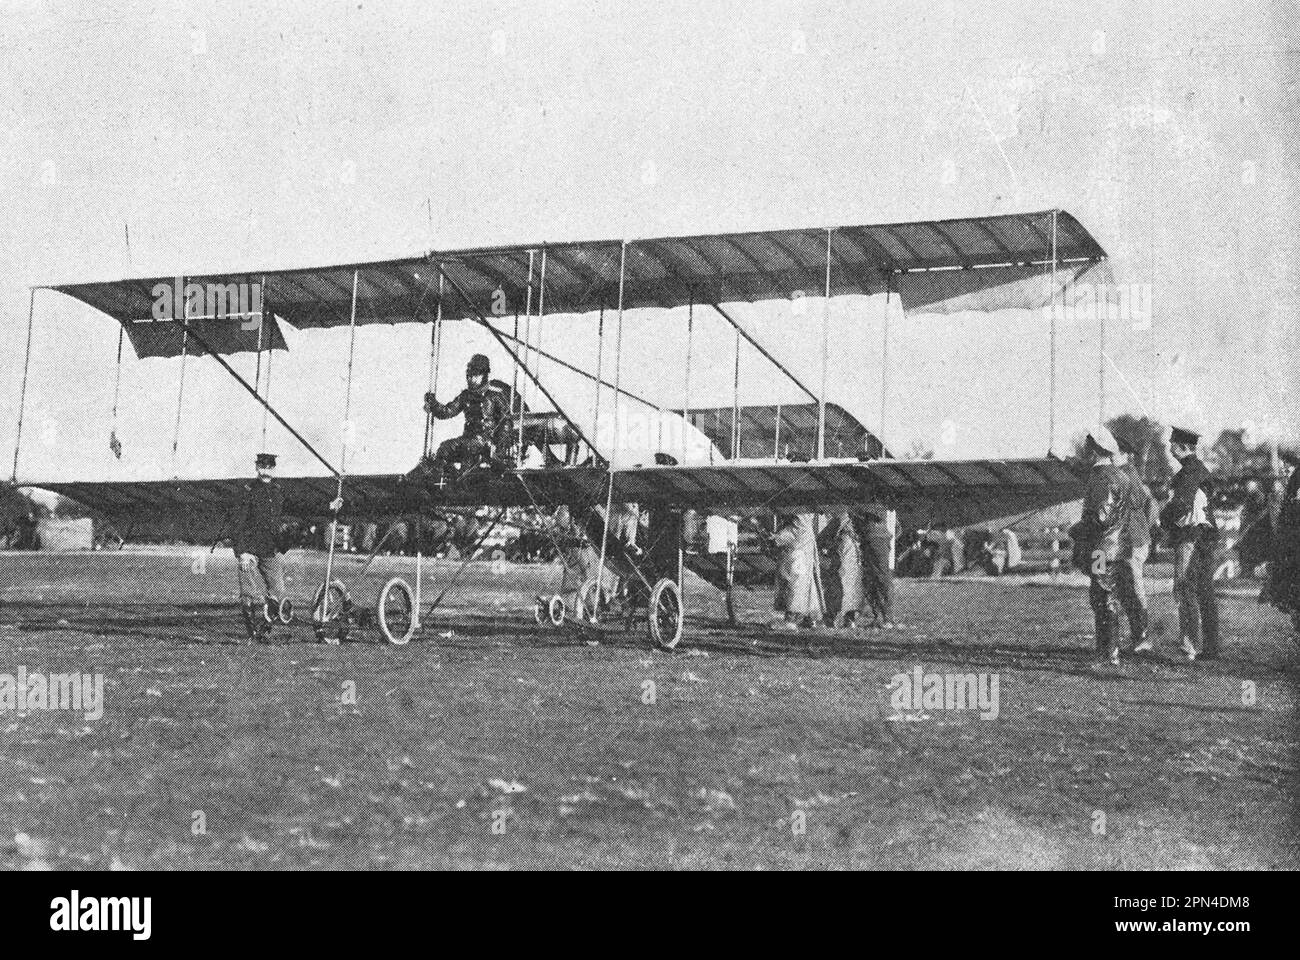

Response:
(33, 458), (1084, 539)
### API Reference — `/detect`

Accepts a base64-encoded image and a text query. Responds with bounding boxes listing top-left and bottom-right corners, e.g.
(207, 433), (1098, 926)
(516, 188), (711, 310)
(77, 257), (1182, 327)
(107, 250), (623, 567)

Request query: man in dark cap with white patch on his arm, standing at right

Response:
(1161, 427), (1219, 661)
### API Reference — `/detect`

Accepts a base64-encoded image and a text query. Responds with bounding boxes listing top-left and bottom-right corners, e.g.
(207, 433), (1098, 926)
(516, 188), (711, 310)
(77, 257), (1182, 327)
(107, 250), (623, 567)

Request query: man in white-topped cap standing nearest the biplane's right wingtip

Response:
(1070, 427), (1131, 666)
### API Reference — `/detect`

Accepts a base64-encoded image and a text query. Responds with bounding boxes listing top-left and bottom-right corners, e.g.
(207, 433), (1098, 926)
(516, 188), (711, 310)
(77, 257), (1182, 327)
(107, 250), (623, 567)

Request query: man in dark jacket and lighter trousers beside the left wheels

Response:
(231, 453), (292, 640)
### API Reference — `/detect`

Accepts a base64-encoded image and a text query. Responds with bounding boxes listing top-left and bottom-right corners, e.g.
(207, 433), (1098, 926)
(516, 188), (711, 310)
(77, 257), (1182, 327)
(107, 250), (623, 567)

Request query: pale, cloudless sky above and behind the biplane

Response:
(0, 0), (1300, 481)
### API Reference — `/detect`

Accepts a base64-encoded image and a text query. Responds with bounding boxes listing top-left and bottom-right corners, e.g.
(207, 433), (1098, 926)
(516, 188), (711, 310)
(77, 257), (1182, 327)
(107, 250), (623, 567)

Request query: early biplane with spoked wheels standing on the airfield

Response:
(13, 209), (1109, 648)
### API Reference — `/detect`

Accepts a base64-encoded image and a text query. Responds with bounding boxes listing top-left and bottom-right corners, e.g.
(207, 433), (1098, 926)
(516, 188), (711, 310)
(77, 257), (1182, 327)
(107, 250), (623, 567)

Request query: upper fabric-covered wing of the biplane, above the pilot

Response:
(49, 211), (1106, 356)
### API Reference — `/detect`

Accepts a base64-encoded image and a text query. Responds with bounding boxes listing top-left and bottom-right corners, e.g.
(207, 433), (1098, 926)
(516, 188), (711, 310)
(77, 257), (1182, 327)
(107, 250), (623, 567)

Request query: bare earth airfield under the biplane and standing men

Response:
(0, 550), (1300, 869)
